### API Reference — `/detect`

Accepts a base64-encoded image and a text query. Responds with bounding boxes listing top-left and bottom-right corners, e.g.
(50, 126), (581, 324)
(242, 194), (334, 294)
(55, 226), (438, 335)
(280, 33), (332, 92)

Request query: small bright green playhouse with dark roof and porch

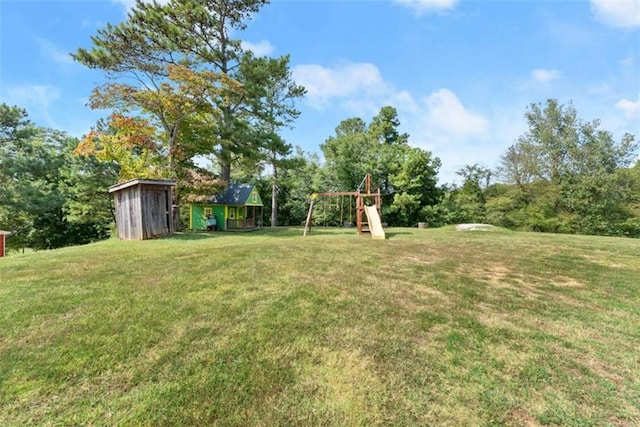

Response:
(189, 184), (264, 231)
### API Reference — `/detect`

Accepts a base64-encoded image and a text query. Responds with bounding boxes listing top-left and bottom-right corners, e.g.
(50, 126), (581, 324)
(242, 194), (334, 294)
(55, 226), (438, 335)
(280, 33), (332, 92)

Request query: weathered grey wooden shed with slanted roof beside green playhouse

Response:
(109, 179), (176, 240)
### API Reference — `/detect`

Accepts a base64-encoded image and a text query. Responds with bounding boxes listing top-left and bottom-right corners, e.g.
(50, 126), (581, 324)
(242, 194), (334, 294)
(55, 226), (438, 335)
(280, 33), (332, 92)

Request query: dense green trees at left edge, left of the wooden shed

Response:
(0, 104), (116, 249)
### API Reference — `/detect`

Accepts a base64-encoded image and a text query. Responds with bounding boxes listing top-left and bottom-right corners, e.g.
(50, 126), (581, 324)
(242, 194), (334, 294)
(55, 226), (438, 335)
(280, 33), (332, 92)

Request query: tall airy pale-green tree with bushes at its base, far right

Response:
(490, 99), (638, 235)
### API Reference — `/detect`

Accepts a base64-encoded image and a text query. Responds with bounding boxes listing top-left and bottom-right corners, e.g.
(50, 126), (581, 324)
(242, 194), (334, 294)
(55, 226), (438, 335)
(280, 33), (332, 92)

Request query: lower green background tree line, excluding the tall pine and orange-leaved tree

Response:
(0, 95), (640, 254)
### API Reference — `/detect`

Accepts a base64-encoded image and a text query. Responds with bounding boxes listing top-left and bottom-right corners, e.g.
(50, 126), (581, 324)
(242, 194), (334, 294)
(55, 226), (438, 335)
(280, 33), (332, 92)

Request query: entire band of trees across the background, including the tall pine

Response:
(0, 0), (640, 249)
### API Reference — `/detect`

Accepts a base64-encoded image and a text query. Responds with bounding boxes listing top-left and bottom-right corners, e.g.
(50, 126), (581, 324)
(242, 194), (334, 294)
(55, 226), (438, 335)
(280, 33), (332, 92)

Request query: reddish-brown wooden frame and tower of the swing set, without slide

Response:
(302, 173), (382, 237)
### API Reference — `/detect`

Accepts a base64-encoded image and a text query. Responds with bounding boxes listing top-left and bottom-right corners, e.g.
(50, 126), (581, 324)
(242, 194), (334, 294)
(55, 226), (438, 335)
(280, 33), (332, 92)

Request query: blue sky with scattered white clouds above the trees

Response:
(0, 0), (640, 182)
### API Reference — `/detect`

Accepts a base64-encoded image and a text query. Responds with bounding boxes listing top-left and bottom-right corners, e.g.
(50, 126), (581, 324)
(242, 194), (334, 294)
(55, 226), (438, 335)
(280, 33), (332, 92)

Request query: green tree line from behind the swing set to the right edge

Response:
(244, 99), (640, 237)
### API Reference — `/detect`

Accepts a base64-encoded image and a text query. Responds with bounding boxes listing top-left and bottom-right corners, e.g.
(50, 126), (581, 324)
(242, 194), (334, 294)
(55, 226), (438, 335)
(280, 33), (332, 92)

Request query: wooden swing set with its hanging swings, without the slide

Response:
(302, 173), (382, 236)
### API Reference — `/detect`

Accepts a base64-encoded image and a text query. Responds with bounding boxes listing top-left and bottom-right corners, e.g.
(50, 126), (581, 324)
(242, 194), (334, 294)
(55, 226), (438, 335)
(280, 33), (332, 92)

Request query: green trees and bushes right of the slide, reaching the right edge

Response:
(426, 99), (640, 237)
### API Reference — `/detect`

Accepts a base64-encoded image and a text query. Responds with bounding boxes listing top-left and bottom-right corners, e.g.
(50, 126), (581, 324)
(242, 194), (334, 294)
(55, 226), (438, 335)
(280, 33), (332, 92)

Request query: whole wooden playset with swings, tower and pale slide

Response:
(303, 174), (386, 240)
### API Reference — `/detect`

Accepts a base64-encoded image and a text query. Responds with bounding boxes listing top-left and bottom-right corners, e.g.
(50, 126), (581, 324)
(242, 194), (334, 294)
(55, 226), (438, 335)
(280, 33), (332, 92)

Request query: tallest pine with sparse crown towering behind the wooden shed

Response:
(74, 0), (266, 187)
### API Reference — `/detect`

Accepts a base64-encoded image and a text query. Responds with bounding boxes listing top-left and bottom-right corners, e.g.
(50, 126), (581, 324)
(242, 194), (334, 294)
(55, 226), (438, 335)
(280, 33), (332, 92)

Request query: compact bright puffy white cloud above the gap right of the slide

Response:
(423, 89), (489, 135)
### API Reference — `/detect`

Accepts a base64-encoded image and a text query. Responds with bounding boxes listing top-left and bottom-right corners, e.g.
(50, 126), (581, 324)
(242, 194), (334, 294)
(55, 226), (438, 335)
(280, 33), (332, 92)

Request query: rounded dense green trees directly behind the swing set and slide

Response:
(319, 106), (440, 226)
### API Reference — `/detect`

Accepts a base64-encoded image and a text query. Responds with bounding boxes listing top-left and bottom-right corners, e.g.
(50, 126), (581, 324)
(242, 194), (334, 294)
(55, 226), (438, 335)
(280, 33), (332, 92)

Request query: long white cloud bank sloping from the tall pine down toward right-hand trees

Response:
(292, 62), (501, 186)
